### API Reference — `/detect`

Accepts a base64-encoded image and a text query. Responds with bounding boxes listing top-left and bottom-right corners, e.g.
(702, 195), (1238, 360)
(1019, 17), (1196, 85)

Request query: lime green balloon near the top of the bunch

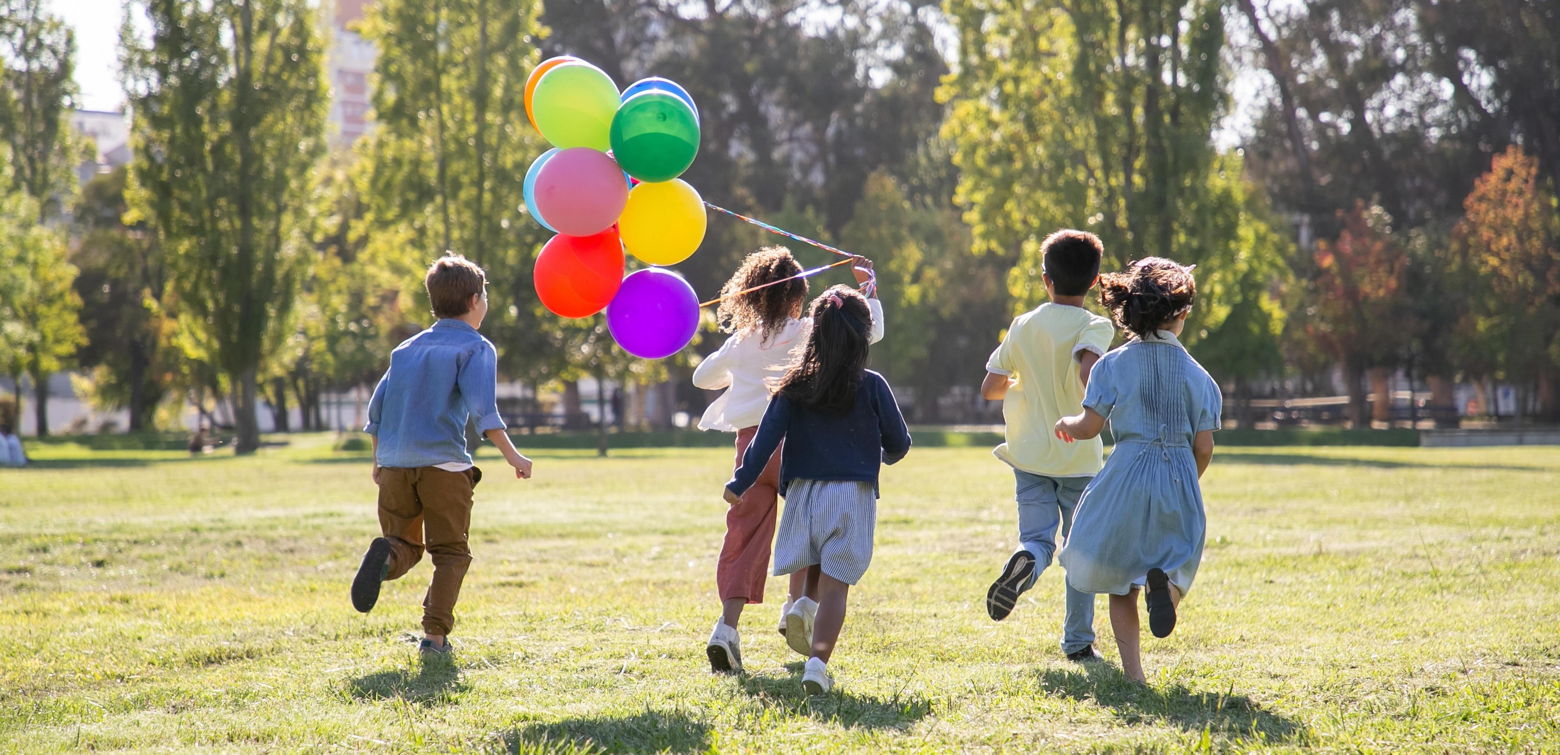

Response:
(530, 62), (618, 151)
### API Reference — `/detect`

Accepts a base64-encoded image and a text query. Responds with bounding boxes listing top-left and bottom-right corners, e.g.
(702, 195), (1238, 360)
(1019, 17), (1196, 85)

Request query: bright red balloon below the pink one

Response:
(532, 228), (622, 318)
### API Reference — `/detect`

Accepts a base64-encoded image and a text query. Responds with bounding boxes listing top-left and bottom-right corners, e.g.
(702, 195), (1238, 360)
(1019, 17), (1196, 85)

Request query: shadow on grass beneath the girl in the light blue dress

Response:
(1039, 663), (1310, 744)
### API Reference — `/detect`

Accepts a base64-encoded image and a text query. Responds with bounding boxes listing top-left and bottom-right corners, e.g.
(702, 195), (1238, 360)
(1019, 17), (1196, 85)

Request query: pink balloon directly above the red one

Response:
(537, 147), (629, 236)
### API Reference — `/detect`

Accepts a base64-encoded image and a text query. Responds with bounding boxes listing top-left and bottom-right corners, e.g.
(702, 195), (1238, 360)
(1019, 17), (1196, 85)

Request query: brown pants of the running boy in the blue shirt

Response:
(379, 466), (482, 635)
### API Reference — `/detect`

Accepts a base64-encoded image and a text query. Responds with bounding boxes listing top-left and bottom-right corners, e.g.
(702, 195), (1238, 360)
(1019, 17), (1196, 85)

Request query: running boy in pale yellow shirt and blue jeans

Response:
(981, 229), (1115, 660)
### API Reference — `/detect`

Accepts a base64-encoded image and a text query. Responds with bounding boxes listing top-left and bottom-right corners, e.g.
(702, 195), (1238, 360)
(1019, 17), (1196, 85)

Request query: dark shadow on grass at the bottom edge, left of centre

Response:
(499, 710), (710, 752)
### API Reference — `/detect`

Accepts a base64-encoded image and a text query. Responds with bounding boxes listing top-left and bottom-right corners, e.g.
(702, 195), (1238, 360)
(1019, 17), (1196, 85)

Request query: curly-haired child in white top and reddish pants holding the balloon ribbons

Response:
(693, 246), (883, 672)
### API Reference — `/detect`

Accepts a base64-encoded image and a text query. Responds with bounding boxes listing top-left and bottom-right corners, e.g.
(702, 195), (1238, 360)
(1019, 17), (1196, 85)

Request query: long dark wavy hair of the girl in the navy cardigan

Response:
(780, 285), (872, 413)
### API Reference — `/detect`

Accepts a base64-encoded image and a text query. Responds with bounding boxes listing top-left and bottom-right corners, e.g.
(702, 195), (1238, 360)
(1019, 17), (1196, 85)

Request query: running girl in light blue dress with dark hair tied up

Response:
(1056, 257), (1223, 682)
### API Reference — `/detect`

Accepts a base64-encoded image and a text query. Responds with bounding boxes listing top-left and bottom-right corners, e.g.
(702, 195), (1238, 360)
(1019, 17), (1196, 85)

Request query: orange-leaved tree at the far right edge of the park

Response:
(1452, 147), (1560, 420)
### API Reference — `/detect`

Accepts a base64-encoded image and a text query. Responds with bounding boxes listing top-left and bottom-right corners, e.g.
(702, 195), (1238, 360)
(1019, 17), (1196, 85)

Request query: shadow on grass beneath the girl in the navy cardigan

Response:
(736, 663), (931, 728)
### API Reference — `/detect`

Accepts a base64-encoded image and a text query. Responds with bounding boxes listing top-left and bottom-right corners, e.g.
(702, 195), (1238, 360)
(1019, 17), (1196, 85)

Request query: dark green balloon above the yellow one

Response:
(608, 90), (699, 183)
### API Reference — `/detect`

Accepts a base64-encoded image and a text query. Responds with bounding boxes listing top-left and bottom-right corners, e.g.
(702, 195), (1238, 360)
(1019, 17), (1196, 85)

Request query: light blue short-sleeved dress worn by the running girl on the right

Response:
(1059, 331), (1223, 594)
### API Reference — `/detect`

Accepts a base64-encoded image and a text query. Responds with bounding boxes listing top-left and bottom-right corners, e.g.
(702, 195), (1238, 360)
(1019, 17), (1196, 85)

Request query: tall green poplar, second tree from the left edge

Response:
(123, 0), (326, 454)
